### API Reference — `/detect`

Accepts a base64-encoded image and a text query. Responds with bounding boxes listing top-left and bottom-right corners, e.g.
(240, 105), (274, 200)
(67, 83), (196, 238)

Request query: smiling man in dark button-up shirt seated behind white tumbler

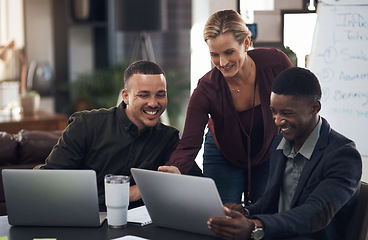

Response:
(42, 61), (200, 208)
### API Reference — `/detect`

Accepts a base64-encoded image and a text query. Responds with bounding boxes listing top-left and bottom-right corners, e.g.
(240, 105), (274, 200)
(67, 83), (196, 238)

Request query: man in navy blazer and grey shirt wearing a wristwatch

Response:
(208, 67), (362, 240)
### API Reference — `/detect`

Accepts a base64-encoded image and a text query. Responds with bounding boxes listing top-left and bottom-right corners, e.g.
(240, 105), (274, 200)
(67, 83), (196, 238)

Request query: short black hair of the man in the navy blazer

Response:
(272, 67), (322, 102)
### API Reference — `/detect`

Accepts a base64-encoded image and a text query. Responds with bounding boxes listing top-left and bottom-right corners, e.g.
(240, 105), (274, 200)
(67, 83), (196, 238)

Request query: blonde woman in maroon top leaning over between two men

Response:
(159, 10), (292, 203)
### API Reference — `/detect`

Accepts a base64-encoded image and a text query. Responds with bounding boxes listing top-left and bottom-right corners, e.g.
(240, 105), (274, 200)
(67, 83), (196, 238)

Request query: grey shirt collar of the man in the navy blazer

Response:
(276, 117), (322, 160)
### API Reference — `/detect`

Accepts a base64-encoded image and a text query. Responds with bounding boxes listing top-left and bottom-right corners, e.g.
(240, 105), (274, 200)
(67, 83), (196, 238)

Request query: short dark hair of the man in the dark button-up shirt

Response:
(124, 60), (166, 86)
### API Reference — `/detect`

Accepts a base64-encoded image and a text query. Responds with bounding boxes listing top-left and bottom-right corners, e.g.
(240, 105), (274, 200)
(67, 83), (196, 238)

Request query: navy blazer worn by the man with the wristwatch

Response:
(248, 118), (362, 240)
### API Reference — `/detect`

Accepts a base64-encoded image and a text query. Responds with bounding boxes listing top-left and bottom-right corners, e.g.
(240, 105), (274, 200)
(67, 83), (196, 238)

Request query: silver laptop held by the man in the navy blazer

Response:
(131, 168), (225, 236)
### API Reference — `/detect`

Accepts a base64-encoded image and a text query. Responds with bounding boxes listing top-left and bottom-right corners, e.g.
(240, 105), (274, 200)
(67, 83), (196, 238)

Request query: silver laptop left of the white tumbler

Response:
(2, 169), (106, 227)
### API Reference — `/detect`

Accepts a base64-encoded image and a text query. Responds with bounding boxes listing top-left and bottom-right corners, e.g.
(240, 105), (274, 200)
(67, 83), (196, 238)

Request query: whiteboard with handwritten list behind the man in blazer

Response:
(307, 0), (368, 156)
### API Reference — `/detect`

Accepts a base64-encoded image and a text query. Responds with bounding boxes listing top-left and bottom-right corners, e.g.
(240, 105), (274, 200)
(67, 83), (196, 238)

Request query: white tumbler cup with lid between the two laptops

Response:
(105, 174), (130, 228)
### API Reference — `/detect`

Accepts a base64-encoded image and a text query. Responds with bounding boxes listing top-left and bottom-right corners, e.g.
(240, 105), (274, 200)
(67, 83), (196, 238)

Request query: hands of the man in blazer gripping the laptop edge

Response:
(207, 206), (254, 239)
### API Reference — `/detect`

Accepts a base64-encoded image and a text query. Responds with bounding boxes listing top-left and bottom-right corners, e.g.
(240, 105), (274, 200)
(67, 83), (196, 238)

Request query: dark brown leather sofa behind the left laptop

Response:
(0, 130), (62, 215)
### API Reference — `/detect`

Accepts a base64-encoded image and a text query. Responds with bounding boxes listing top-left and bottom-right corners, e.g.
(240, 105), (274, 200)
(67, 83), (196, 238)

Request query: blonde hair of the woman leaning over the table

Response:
(203, 10), (252, 44)
